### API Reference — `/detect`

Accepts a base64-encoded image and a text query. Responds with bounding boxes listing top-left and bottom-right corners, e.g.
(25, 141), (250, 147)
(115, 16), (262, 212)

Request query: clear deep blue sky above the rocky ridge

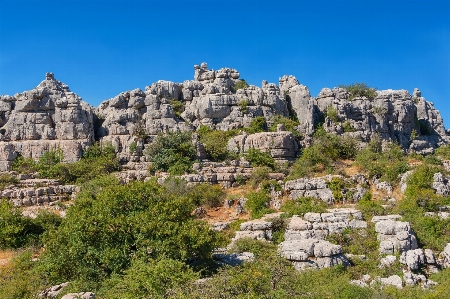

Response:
(0, 0), (450, 126)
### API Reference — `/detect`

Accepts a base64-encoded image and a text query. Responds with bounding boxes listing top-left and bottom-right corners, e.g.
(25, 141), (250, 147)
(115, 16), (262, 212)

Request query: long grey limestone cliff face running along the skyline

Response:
(0, 63), (450, 170)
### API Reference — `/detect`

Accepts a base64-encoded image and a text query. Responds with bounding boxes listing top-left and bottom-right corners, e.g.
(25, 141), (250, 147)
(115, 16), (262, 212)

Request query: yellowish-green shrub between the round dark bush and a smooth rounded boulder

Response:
(197, 126), (238, 162)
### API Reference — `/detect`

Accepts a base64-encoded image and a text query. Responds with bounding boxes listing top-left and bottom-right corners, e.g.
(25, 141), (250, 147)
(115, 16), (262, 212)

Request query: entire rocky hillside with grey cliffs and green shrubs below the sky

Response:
(0, 63), (450, 299)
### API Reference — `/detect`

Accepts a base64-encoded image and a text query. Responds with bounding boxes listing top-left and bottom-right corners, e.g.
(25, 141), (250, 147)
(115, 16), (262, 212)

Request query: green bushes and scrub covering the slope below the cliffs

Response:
(4, 121), (450, 299)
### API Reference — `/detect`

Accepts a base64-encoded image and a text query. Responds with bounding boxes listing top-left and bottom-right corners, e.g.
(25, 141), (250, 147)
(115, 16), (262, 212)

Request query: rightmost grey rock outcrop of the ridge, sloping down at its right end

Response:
(316, 88), (449, 154)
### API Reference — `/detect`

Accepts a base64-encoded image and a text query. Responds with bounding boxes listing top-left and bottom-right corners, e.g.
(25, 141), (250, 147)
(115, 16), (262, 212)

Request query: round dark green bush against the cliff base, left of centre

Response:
(145, 131), (196, 175)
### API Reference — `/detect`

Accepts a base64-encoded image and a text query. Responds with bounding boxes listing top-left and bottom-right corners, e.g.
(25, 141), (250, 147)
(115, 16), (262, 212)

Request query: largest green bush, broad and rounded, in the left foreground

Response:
(41, 180), (217, 282)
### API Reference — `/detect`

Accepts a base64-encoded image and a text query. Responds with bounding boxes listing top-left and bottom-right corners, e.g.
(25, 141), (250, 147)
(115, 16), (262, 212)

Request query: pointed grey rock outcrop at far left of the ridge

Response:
(0, 73), (94, 171)
